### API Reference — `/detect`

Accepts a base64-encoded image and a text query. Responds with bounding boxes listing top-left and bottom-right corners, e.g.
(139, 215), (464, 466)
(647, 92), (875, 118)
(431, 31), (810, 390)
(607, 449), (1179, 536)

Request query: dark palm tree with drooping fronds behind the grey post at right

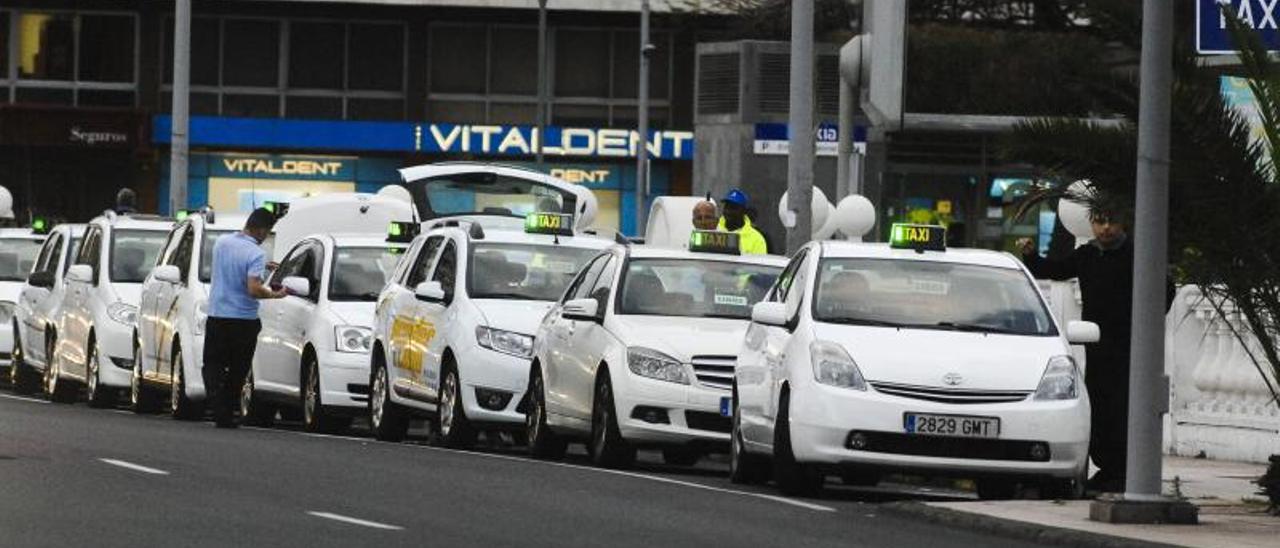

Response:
(1005, 1), (1280, 405)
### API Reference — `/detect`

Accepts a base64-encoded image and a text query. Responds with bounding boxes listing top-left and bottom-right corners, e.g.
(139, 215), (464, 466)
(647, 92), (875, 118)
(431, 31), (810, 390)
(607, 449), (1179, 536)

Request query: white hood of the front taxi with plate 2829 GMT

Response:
(814, 324), (1070, 391)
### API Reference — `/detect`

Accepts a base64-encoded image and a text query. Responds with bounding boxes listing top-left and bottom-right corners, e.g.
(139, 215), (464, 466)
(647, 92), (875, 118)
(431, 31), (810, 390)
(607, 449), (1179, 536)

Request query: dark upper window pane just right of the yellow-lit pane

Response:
(79, 15), (136, 82)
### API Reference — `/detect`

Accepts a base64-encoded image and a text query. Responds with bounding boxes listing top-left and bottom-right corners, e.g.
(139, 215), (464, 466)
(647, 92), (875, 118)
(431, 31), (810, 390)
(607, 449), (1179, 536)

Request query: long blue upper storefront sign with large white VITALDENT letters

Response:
(152, 114), (694, 160)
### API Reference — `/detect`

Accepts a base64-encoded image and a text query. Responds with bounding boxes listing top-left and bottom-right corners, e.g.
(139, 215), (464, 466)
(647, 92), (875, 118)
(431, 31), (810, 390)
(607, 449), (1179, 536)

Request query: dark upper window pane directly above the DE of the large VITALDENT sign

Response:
(556, 29), (611, 97)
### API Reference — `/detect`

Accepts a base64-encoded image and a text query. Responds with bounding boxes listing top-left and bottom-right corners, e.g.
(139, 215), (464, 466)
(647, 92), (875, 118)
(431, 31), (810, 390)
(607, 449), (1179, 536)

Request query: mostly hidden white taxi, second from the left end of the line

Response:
(9, 222), (84, 393)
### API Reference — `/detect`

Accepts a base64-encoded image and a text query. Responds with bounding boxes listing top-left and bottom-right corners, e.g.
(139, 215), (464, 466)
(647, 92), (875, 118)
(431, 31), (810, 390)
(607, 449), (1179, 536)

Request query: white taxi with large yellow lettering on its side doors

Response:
(370, 214), (612, 447)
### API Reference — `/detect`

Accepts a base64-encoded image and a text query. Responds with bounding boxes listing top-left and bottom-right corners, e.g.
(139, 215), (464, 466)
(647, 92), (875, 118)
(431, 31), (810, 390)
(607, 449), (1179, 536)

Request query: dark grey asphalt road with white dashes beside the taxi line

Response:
(0, 393), (1039, 548)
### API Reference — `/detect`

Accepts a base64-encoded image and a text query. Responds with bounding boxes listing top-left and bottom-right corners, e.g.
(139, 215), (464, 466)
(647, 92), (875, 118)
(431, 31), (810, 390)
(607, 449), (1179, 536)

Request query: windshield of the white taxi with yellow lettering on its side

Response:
(467, 243), (600, 301)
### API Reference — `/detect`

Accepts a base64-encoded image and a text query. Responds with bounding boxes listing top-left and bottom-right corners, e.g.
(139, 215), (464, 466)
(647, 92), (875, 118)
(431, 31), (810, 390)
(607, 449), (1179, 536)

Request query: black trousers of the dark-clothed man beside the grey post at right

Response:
(1084, 346), (1129, 481)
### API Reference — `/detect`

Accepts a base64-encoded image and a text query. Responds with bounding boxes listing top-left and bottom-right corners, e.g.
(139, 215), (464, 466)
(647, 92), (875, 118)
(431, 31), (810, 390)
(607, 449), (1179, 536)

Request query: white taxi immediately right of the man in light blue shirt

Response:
(241, 234), (402, 433)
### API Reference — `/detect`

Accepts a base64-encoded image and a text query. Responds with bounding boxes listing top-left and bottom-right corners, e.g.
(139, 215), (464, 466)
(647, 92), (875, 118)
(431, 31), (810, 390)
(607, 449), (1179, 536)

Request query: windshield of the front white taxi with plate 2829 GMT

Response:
(813, 259), (1057, 335)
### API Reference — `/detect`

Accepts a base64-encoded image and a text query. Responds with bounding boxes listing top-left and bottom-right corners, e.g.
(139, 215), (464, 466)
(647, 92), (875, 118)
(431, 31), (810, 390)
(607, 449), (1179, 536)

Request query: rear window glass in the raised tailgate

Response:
(407, 173), (576, 219)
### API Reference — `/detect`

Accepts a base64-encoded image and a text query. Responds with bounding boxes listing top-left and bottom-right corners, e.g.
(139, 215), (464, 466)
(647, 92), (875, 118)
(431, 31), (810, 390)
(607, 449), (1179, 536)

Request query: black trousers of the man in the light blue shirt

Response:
(201, 318), (262, 420)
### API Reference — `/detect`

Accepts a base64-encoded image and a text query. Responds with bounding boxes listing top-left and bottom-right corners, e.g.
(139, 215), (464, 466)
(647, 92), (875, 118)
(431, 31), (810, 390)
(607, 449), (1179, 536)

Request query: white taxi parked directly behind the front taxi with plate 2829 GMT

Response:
(525, 232), (786, 466)
